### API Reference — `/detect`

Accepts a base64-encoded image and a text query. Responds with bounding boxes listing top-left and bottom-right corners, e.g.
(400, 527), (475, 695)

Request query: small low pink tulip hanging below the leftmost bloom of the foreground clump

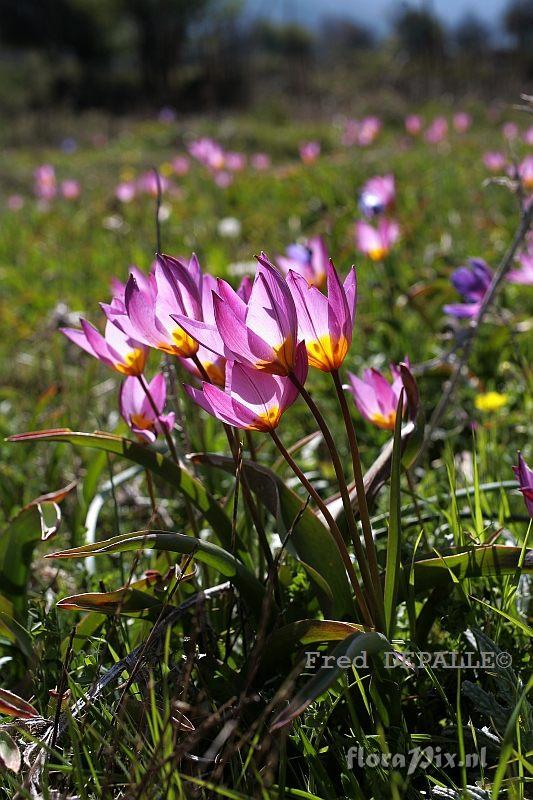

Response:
(118, 374), (175, 442)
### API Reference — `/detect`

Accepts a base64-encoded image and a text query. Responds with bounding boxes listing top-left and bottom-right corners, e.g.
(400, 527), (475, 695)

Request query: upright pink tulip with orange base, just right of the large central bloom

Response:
(287, 260), (357, 372)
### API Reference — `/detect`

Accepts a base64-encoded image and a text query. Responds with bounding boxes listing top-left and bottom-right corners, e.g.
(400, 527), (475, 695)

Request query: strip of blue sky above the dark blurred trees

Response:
(245, 0), (508, 33)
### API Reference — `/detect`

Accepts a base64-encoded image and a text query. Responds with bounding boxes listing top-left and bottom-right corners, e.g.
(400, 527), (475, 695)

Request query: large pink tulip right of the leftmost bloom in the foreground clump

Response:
(125, 255), (203, 358)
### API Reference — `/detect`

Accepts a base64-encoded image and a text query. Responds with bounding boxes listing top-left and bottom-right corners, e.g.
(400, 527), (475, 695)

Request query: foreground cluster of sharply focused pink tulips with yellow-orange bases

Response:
(63, 237), (416, 442)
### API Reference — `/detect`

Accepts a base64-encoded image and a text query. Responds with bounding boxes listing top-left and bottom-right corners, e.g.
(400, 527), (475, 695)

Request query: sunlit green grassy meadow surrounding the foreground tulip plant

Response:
(0, 107), (533, 798)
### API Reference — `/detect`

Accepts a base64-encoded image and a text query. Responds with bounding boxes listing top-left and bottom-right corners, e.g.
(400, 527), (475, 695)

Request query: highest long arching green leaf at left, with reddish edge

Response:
(8, 428), (231, 548)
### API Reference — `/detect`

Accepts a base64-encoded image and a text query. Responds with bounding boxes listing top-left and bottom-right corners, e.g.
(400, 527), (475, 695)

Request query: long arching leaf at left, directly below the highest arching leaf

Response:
(46, 531), (264, 614)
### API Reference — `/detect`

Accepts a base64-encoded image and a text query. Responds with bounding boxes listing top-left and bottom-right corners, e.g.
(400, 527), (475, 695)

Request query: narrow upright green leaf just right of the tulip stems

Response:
(383, 389), (404, 638)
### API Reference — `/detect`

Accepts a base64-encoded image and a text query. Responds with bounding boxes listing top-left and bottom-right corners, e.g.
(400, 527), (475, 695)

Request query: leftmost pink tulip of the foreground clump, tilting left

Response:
(61, 319), (148, 375)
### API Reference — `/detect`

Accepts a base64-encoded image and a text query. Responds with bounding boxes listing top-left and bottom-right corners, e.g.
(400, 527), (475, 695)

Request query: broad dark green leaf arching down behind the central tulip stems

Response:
(190, 453), (353, 617)
